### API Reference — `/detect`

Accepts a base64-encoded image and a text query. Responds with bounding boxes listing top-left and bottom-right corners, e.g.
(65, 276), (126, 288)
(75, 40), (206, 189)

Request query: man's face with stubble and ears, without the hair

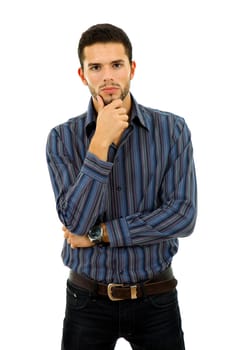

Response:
(78, 43), (136, 104)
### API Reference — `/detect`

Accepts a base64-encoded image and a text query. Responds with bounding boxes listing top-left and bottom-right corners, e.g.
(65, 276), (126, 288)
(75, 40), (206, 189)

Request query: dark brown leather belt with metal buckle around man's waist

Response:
(69, 267), (177, 301)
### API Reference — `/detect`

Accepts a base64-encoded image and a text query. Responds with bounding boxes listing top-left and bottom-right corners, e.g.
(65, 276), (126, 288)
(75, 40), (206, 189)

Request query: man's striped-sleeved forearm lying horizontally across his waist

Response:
(105, 197), (196, 247)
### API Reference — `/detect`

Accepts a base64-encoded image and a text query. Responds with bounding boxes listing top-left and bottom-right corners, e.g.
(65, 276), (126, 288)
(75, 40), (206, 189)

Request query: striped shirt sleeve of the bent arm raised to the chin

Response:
(46, 128), (113, 235)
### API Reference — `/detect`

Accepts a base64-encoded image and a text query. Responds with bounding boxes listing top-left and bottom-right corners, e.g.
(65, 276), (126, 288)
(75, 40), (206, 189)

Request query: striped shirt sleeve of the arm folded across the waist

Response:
(106, 120), (197, 247)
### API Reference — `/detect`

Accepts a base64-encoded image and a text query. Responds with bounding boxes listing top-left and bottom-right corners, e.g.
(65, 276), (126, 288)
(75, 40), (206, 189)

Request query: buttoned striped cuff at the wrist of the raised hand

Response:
(81, 152), (113, 183)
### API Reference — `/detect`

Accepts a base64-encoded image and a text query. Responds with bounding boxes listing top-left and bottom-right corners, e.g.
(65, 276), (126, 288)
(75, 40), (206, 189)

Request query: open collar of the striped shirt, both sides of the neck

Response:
(85, 94), (149, 137)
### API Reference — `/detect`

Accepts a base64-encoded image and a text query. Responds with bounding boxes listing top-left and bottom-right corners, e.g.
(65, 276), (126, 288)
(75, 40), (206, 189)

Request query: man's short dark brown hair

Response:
(78, 23), (132, 67)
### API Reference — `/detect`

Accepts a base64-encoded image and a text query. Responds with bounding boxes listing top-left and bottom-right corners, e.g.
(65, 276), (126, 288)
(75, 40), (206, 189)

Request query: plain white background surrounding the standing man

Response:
(0, 0), (233, 350)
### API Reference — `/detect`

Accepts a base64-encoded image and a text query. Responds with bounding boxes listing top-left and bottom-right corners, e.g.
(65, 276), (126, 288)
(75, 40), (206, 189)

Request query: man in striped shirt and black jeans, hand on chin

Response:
(47, 24), (196, 350)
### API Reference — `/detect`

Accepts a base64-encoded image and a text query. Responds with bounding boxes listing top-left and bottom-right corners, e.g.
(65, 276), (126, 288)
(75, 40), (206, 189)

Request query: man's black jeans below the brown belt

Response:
(61, 280), (185, 350)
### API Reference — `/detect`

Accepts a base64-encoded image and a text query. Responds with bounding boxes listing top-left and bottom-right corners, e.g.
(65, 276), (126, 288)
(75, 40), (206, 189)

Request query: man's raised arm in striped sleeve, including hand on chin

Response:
(46, 98), (128, 235)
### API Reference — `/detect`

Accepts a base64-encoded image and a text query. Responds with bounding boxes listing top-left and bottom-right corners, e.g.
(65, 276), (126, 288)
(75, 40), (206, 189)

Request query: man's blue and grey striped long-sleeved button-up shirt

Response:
(46, 96), (197, 283)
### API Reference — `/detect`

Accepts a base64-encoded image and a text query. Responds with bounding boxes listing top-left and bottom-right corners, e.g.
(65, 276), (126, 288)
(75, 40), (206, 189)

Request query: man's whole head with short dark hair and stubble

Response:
(78, 23), (136, 104)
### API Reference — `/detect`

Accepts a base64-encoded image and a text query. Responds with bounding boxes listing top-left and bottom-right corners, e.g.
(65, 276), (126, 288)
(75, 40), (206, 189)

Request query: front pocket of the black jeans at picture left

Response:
(66, 281), (90, 310)
